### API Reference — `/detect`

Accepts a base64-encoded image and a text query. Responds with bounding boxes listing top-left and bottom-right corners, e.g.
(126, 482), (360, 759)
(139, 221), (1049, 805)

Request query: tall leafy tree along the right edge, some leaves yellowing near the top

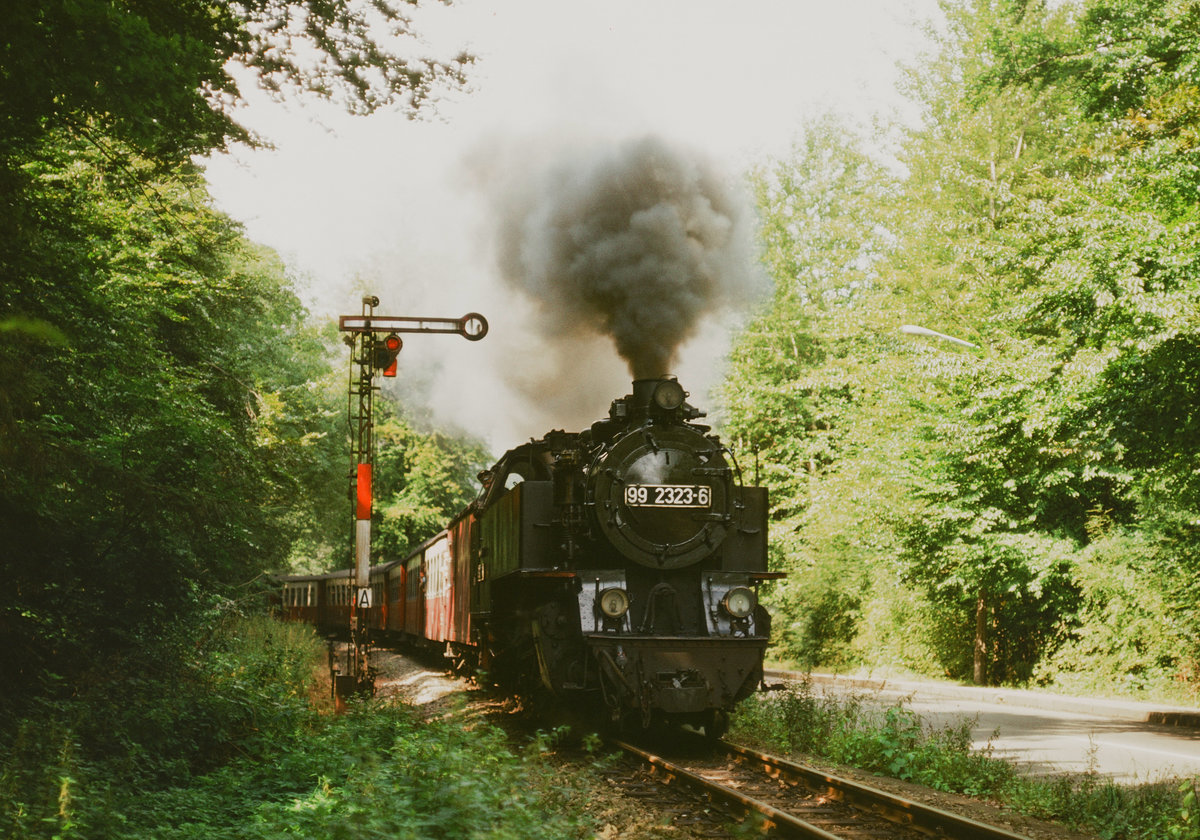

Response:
(979, 0), (1200, 680)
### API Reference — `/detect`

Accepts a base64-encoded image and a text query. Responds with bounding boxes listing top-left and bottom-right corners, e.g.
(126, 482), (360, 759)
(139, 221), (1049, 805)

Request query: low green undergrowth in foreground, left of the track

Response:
(0, 609), (590, 840)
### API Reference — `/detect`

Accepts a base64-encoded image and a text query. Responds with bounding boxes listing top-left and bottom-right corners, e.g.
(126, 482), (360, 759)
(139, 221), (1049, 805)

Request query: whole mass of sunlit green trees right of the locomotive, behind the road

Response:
(730, 0), (1200, 685)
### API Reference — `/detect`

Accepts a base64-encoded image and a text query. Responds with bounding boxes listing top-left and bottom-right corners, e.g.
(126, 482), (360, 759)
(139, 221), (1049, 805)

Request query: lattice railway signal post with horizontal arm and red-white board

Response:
(330, 295), (487, 697)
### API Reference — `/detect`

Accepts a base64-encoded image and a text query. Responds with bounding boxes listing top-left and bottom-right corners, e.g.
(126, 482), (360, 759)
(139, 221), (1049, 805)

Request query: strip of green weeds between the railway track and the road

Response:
(731, 682), (1200, 840)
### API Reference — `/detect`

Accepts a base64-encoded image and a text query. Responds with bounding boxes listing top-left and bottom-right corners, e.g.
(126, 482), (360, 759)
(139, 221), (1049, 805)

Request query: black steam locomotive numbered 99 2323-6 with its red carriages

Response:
(283, 377), (781, 737)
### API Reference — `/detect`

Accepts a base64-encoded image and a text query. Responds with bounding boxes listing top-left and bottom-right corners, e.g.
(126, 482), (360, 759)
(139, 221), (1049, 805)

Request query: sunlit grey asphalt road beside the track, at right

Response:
(768, 674), (1200, 784)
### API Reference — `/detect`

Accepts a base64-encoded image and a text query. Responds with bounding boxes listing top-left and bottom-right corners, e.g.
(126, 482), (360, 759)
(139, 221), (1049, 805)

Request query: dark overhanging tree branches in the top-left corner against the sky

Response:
(0, 0), (470, 163)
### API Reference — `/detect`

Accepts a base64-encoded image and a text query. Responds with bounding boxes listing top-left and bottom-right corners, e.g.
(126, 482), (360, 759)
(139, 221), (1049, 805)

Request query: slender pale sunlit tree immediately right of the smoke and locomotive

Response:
(722, 116), (894, 664)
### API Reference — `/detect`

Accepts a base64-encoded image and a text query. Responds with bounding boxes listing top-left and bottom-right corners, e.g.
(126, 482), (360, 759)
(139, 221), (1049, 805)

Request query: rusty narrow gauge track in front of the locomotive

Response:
(614, 742), (1028, 840)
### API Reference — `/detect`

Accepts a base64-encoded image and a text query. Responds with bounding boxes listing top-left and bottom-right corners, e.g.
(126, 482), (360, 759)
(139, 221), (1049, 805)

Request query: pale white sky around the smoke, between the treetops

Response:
(208, 0), (936, 449)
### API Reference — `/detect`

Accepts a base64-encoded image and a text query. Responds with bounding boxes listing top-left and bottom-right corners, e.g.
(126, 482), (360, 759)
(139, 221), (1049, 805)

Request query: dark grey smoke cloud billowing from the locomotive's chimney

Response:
(485, 138), (761, 384)
